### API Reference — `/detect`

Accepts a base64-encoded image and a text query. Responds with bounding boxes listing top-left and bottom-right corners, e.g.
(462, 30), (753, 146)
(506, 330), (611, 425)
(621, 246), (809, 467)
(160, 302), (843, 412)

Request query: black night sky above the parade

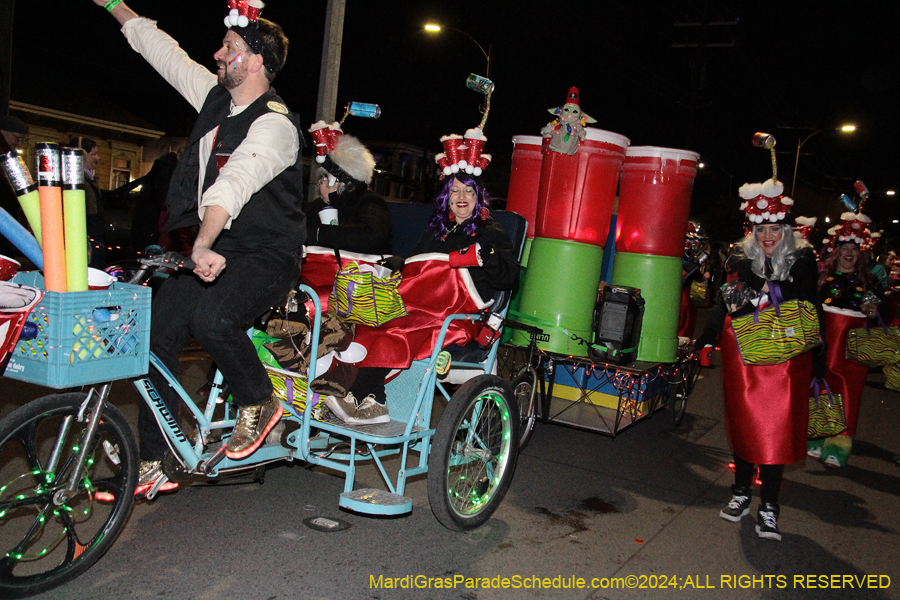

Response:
(12, 0), (900, 245)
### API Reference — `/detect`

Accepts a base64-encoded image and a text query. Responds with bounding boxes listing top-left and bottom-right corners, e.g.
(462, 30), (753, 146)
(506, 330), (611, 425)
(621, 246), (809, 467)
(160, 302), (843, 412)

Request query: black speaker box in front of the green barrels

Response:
(588, 285), (644, 365)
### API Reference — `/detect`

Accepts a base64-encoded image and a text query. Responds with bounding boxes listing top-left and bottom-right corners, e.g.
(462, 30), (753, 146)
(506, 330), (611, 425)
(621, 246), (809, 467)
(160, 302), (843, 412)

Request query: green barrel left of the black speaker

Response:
(510, 237), (603, 356)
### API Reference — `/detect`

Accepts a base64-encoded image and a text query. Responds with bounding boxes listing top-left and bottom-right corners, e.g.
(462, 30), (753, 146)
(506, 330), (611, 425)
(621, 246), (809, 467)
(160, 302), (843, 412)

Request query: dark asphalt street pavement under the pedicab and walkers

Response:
(0, 314), (900, 600)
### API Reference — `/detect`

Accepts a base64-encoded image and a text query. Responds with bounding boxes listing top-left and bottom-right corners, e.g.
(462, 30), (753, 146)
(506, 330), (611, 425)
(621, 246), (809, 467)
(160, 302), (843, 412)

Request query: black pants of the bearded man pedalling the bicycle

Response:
(138, 250), (300, 460)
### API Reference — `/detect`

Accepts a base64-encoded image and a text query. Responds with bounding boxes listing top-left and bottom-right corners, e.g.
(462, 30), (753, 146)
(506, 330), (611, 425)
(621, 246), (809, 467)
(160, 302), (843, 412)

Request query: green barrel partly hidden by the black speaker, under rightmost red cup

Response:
(612, 252), (681, 362)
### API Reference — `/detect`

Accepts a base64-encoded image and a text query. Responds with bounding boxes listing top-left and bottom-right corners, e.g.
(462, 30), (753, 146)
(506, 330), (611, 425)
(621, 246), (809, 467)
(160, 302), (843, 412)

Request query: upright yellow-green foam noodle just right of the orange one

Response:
(62, 148), (88, 292)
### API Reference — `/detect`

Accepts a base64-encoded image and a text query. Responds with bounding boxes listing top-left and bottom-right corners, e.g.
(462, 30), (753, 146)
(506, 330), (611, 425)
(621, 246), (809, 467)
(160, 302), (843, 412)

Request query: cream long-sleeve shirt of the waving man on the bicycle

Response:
(122, 17), (300, 229)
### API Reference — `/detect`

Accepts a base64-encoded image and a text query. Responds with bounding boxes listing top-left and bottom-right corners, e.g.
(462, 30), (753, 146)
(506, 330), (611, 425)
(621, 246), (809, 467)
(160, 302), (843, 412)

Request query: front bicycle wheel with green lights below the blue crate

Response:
(0, 392), (138, 598)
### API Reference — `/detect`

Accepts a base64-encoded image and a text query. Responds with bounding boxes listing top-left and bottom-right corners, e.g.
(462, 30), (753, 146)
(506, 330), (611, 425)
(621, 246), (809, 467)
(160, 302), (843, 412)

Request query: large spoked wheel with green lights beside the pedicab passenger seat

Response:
(428, 375), (519, 531)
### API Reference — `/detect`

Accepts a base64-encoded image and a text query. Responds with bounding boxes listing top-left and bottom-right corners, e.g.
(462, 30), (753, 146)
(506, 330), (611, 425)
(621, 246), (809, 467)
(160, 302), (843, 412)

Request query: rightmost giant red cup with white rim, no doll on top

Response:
(616, 146), (700, 256)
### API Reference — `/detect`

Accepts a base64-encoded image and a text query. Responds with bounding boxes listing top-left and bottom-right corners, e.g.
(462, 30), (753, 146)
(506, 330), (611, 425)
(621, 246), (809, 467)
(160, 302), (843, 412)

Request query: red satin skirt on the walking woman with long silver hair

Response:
(721, 317), (813, 465)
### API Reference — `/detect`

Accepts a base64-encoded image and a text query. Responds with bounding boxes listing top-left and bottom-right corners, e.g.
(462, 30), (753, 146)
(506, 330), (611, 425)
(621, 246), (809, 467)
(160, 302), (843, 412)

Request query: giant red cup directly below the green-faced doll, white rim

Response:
(534, 127), (631, 247)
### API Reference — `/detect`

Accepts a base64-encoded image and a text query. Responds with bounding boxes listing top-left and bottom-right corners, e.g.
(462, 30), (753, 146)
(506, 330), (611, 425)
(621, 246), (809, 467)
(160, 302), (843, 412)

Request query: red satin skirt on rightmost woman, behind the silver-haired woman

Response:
(825, 308), (869, 435)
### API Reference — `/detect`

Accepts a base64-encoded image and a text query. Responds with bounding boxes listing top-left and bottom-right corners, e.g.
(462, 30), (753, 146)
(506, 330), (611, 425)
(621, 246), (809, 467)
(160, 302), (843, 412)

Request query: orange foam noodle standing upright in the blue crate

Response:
(35, 143), (66, 292)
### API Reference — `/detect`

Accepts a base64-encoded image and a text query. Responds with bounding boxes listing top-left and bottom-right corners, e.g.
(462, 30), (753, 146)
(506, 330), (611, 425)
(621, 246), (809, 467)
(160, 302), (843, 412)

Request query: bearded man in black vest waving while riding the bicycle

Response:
(93, 0), (306, 492)
